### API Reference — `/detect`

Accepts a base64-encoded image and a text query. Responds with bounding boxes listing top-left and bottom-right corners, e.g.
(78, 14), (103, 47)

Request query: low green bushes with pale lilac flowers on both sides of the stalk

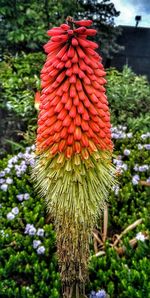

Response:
(0, 127), (150, 298)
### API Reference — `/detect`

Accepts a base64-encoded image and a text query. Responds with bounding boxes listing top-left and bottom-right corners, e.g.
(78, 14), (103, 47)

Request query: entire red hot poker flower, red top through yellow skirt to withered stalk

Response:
(33, 17), (114, 297)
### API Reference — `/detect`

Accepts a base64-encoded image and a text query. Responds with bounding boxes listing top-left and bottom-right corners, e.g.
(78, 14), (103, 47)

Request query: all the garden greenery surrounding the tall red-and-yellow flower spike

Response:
(0, 1), (150, 298)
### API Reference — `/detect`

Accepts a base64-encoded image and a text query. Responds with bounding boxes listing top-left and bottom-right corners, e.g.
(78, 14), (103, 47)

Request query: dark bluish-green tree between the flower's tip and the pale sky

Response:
(78, 0), (121, 58)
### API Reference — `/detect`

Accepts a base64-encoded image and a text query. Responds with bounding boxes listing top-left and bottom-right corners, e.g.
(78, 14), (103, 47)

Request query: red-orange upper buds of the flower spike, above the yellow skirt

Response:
(37, 19), (112, 159)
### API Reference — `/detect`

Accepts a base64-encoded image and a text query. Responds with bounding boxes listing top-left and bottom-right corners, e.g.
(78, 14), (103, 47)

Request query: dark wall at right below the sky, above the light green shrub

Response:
(111, 26), (150, 79)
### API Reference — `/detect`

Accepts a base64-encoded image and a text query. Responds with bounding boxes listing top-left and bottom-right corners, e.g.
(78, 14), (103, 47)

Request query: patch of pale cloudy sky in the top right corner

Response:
(112, 0), (150, 27)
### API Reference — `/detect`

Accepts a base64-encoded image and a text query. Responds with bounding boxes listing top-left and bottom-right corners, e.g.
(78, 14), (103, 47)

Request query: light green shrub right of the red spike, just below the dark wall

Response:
(107, 66), (150, 131)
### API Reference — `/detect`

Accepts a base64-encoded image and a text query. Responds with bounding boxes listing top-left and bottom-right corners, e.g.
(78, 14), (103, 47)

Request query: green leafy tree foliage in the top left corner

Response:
(0, 0), (78, 53)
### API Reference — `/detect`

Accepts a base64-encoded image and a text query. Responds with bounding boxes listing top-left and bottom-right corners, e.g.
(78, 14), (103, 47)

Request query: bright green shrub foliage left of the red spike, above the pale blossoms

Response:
(0, 53), (45, 155)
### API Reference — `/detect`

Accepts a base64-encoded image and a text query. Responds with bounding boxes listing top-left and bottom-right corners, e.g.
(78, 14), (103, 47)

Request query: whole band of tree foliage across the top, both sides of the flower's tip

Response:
(0, 0), (120, 57)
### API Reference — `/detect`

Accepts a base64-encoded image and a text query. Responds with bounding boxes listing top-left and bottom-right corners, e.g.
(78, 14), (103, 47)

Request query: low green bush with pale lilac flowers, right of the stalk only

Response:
(89, 127), (150, 298)
